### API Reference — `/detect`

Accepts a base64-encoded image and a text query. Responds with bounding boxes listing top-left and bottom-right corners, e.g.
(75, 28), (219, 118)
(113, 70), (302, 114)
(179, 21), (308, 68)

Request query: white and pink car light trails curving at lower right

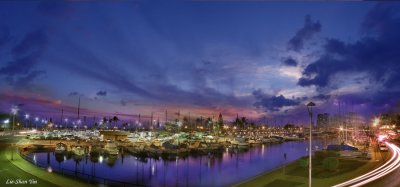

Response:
(333, 142), (400, 187)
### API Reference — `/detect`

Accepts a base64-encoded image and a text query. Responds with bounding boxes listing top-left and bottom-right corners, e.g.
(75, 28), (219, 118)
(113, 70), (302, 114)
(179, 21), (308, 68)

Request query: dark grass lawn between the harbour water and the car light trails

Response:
(234, 149), (389, 187)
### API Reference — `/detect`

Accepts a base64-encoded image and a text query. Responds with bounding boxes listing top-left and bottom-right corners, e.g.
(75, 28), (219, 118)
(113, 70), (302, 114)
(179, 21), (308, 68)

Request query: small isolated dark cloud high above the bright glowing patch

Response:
(287, 15), (321, 52)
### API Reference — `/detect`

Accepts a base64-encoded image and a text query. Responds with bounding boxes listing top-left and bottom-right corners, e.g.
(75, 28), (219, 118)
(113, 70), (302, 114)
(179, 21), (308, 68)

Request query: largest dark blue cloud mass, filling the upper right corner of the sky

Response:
(298, 4), (400, 107)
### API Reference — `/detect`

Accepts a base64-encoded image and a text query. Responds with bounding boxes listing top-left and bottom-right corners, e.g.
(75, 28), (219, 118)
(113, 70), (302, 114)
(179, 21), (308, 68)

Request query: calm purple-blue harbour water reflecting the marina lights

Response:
(30, 140), (331, 186)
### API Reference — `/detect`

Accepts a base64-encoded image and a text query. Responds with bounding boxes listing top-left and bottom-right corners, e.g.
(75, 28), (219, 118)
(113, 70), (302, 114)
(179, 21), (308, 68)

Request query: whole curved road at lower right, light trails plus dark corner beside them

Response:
(334, 142), (400, 187)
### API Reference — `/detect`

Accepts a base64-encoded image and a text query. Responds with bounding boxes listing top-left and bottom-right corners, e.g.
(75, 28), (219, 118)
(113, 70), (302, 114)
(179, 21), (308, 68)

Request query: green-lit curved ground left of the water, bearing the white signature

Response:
(0, 136), (56, 187)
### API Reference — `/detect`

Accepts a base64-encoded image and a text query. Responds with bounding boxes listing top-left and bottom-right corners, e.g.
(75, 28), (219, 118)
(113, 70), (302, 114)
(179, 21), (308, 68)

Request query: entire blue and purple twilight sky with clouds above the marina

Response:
(0, 1), (400, 124)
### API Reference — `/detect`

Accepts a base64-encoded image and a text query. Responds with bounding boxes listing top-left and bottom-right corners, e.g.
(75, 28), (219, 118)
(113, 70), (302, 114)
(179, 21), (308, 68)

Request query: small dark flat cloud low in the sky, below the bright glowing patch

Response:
(253, 90), (300, 112)
